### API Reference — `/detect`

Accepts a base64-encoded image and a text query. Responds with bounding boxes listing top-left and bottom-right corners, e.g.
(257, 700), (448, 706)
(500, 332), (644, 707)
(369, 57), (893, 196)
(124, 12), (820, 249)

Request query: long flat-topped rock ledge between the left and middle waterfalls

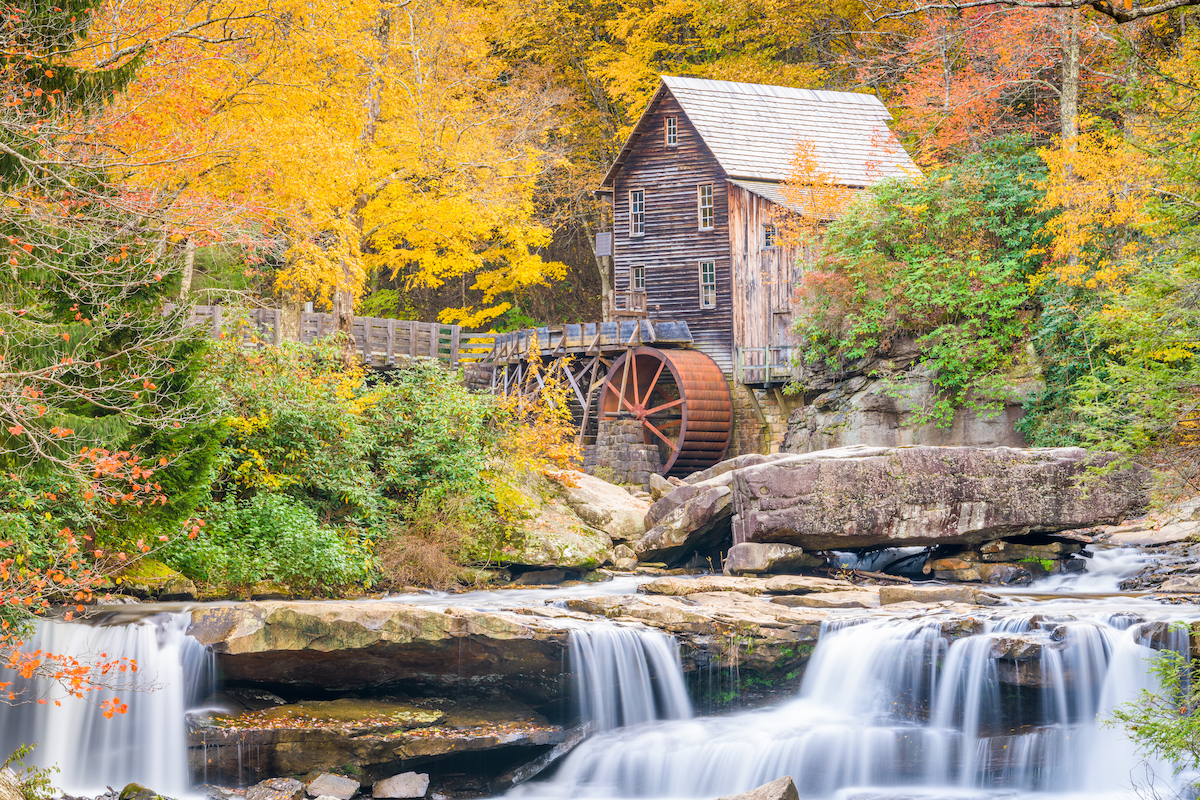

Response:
(188, 601), (570, 705)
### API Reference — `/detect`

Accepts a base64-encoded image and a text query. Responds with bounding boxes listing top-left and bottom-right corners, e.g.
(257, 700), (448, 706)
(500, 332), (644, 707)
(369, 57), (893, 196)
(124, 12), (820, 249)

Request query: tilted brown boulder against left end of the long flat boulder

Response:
(634, 479), (733, 564)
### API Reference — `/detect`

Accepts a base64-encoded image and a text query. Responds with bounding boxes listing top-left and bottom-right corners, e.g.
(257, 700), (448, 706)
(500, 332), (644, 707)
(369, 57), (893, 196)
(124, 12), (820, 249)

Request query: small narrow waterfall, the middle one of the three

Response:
(570, 625), (691, 730)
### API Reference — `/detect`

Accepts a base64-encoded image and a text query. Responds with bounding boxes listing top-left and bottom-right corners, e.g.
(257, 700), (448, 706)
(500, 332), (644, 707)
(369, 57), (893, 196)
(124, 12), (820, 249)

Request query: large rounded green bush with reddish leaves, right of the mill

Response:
(797, 143), (1044, 423)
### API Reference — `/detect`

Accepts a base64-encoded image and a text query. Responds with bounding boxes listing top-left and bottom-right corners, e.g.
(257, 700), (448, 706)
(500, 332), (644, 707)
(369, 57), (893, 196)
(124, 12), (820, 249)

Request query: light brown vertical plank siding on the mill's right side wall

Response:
(730, 185), (804, 348)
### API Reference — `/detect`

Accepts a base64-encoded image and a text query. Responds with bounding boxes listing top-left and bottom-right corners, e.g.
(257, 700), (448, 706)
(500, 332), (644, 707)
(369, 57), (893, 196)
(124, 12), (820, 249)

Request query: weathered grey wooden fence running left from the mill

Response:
(192, 306), (496, 368)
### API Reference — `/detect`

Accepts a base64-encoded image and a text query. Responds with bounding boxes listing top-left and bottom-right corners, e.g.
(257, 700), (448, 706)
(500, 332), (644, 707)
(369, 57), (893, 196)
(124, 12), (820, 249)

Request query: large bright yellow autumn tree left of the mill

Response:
(102, 0), (563, 327)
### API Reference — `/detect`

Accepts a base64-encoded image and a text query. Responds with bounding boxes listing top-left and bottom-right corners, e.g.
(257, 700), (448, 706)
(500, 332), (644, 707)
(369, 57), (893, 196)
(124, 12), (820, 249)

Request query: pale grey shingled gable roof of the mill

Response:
(604, 76), (918, 186)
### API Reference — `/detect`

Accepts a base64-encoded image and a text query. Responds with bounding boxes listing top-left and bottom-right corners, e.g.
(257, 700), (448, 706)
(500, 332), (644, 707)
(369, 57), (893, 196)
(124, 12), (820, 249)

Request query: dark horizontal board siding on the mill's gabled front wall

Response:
(613, 94), (734, 374)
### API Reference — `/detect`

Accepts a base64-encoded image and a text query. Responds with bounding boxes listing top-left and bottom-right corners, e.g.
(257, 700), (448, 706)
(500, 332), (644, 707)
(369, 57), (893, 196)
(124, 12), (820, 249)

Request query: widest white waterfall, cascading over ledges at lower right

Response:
(514, 609), (1187, 800)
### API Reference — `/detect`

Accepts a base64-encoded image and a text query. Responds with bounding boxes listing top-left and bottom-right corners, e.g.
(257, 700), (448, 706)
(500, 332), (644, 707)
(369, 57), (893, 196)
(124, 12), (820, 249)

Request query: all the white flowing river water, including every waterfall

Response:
(0, 549), (1200, 800)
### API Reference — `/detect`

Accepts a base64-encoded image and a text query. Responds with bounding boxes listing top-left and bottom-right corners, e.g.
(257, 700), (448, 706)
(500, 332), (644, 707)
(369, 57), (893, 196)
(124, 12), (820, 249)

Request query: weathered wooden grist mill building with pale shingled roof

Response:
(596, 76), (917, 455)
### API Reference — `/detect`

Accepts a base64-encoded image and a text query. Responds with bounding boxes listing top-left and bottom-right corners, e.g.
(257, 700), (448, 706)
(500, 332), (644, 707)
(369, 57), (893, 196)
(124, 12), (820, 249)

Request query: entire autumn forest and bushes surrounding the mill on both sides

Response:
(7, 0), (1200, 618)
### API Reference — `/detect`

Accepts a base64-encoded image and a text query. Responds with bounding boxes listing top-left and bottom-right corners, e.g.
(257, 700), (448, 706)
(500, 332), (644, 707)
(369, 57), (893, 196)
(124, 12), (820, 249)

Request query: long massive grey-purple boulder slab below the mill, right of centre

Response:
(724, 447), (1150, 549)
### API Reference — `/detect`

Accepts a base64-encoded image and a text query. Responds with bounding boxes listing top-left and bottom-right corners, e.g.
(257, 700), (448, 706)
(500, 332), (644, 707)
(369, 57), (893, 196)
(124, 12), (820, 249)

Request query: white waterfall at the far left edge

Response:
(0, 613), (215, 796)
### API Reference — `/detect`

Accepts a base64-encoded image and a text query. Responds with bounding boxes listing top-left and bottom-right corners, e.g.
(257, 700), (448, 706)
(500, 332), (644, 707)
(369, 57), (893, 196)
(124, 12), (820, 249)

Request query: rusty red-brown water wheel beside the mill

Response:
(598, 347), (733, 476)
